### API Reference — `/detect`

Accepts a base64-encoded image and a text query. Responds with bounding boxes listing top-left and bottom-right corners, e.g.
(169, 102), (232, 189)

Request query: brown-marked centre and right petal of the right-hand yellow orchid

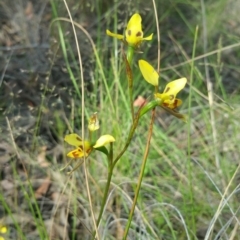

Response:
(154, 78), (187, 109)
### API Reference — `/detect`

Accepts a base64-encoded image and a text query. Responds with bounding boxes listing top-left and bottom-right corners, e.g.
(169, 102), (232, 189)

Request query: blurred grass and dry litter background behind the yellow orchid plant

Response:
(0, 0), (240, 240)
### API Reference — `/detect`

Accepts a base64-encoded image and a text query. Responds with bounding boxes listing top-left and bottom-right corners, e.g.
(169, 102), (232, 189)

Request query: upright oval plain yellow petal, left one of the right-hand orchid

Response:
(138, 59), (159, 86)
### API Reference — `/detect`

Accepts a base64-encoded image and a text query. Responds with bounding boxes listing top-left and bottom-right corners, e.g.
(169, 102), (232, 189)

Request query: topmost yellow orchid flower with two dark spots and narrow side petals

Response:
(106, 13), (153, 46)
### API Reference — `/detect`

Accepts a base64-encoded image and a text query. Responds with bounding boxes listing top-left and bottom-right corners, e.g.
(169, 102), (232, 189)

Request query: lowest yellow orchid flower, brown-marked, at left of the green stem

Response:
(64, 133), (115, 159)
